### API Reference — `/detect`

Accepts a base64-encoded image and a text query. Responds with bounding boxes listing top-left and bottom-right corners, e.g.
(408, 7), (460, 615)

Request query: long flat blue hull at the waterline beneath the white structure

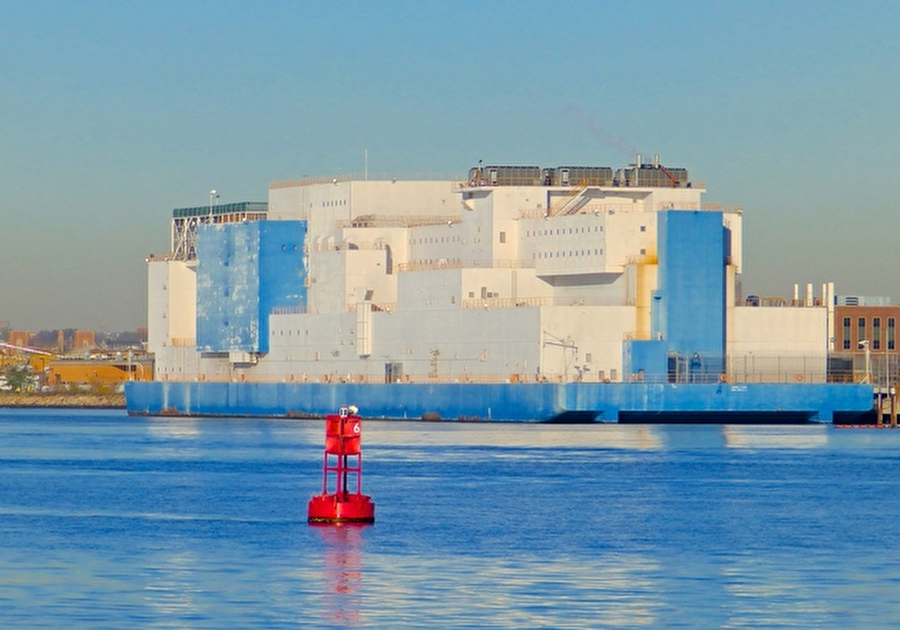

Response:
(125, 381), (874, 423)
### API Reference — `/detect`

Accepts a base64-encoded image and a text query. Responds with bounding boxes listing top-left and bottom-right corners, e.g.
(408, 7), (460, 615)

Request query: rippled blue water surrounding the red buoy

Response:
(0, 410), (900, 628)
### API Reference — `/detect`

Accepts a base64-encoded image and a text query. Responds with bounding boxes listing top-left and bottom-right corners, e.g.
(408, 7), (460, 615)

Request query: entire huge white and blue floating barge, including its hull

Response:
(126, 157), (873, 422)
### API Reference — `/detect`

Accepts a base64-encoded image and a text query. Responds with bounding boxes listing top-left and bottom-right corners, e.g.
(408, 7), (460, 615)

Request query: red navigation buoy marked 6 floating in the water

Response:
(309, 407), (375, 523)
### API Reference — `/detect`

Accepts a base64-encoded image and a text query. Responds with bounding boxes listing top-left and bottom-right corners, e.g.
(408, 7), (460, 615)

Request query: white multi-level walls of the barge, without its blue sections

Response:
(142, 162), (828, 382)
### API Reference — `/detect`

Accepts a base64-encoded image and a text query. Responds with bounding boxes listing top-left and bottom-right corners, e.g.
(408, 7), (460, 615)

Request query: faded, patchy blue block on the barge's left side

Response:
(197, 221), (306, 352)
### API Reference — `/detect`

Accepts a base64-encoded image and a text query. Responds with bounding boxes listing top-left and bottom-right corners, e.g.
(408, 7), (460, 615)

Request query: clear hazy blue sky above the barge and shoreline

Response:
(0, 0), (900, 332)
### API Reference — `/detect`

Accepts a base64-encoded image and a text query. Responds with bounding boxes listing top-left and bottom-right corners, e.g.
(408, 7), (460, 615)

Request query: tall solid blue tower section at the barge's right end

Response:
(623, 210), (731, 383)
